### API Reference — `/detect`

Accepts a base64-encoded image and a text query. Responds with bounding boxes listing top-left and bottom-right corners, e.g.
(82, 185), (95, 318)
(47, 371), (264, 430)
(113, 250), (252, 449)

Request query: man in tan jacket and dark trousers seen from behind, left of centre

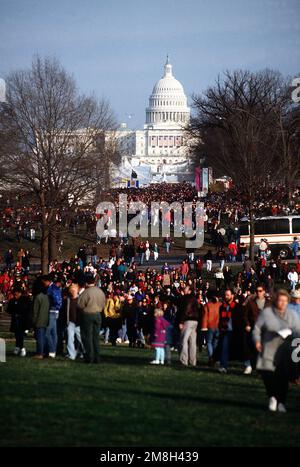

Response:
(78, 274), (106, 363)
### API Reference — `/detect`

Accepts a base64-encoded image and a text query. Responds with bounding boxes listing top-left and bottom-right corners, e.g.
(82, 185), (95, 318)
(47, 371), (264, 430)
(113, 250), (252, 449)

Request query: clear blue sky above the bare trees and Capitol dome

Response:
(0, 0), (300, 129)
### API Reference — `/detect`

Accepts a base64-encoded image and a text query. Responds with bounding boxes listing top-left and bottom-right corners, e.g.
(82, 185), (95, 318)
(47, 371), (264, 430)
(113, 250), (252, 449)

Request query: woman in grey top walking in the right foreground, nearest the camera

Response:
(253, 289), (300, 413)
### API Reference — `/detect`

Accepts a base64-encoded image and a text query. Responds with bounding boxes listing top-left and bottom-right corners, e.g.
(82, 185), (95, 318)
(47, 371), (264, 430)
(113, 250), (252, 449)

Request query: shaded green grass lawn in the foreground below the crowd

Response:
(0, 343), (300, 447)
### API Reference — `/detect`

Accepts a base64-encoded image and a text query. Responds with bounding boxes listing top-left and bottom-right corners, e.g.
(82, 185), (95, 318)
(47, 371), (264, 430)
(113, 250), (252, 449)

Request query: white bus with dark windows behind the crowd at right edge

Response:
(239, 216), (300, 259)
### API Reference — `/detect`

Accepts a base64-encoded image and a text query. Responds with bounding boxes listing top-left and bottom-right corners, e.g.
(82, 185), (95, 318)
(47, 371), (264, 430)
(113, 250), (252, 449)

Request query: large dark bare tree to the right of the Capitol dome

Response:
(188, 70), (282, 259)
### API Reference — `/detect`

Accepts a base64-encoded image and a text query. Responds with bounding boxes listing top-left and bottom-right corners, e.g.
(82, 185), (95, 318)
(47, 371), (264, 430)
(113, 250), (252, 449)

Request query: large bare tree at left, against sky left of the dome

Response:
(2, 57), (115, 272)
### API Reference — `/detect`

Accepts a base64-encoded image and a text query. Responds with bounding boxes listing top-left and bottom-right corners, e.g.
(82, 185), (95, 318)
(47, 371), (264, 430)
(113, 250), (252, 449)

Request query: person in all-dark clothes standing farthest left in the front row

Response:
(7, 287), (31, 357)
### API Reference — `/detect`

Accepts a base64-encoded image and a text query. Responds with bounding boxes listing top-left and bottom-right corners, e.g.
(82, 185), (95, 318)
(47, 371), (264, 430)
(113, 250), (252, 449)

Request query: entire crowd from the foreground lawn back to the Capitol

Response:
(0, 183), (300, 412)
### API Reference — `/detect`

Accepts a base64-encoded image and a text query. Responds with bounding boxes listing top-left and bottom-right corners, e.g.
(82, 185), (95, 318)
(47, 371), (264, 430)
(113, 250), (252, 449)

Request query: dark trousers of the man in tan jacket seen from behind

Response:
(80, 313), (101, 363)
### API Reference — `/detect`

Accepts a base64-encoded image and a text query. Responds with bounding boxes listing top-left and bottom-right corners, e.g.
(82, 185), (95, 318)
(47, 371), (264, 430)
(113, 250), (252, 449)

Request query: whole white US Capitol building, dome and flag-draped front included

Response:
(115, 58), (193, 184)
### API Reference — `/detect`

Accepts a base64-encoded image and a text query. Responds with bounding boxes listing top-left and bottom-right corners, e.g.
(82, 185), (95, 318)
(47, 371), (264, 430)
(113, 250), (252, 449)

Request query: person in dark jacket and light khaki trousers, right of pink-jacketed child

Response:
(178, 287), (200, 366)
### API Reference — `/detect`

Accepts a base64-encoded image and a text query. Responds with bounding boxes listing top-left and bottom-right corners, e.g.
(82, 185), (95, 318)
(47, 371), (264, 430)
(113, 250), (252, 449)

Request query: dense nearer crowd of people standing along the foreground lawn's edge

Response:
(0, 238), (300, 411)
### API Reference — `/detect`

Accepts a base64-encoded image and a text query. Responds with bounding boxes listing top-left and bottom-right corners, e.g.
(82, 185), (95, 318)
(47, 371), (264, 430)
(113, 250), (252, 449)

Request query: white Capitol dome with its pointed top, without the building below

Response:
(146, 58), (190, 127)
